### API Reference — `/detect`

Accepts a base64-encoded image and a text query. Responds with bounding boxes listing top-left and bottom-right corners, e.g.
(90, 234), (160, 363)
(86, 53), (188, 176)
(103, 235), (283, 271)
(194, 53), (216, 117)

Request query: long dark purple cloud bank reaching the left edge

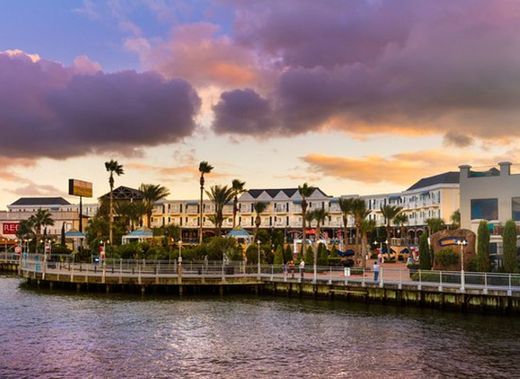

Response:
(0, 49), (200, 158)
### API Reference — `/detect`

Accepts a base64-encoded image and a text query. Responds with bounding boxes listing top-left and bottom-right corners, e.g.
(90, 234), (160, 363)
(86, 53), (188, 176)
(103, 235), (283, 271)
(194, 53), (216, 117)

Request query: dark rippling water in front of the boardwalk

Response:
(0, 277), (520, 378)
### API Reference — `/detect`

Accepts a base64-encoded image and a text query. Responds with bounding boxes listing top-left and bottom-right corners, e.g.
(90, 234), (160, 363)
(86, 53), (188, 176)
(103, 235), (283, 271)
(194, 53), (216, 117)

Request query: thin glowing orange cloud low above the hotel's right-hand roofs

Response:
(301, 150), (484, 186)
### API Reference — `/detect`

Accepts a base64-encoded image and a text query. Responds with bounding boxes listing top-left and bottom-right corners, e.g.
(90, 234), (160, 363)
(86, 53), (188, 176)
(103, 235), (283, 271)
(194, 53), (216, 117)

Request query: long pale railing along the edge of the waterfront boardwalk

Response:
(13, 254), (520, 296)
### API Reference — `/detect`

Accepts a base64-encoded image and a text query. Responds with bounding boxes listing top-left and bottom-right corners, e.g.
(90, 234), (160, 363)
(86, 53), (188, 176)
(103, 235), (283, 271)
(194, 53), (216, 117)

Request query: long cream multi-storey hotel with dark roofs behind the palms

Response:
(152, 172), (459, 243)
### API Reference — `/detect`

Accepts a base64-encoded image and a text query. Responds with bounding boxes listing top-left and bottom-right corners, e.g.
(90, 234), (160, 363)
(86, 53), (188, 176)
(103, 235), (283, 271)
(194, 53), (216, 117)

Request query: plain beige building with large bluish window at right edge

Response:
(459, 162), (520, 265)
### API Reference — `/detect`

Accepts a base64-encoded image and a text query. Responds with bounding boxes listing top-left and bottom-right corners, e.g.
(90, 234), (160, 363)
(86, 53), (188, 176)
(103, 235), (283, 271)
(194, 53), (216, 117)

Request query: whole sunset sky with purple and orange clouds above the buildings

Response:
(0, 0), (520, 209)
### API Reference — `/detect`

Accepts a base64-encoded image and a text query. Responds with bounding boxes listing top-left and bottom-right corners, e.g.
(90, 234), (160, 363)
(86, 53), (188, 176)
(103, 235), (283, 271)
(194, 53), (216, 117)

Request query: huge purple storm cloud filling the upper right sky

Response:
(214, 0), (520, 140)
